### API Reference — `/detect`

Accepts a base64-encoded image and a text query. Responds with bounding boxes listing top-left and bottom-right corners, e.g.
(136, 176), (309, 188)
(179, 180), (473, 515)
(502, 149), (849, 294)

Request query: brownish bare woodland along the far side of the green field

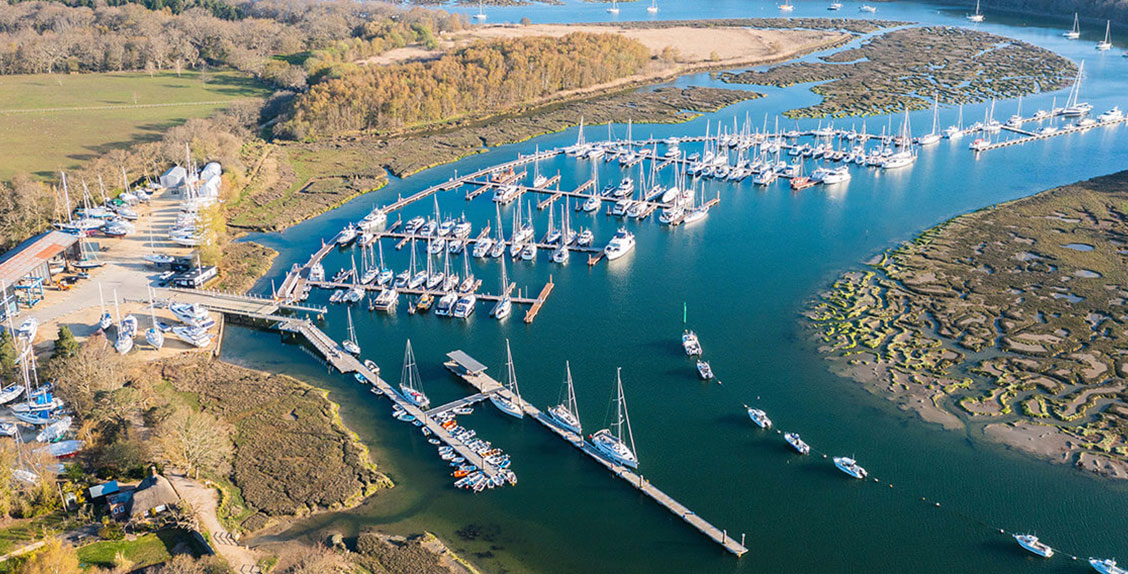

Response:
(0, 0), (462, 88)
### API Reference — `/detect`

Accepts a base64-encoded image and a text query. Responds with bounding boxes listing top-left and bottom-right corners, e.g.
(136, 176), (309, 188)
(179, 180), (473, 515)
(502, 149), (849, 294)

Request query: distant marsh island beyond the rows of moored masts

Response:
(723, 26), (1077, 118)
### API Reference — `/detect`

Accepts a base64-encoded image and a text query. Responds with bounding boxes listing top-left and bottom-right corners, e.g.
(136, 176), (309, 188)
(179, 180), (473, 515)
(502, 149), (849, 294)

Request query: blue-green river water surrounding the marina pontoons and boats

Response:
(224, 0), (1128, 573)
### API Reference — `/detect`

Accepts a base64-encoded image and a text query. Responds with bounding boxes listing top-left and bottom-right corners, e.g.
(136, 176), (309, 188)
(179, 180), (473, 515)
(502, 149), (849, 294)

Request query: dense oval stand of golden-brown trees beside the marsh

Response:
(274, 33), (650, 140)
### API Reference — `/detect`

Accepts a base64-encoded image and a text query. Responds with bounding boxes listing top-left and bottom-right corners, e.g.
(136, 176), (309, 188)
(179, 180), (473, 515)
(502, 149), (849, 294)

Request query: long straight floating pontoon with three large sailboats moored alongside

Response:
(444, 361), (748, 556)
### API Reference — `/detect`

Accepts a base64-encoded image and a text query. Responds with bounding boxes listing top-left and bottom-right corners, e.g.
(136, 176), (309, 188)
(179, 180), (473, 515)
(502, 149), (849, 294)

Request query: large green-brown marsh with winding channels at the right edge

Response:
(810, 171), (1128, 478)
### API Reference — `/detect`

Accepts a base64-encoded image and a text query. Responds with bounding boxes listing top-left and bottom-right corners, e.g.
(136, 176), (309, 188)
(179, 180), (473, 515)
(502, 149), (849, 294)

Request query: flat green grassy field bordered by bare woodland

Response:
(0, 71), (268, 179)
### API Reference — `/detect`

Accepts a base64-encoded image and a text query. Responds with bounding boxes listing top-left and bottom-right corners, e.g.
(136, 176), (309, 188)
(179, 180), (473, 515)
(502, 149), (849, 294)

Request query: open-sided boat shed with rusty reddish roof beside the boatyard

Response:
(0, 231), (78, 319)
